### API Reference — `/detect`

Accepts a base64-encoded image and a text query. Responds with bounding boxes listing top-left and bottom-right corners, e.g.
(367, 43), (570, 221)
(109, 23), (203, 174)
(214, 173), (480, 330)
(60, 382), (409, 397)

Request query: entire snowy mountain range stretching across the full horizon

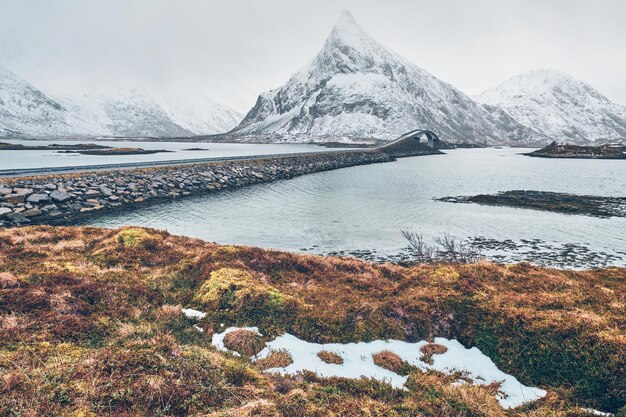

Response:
(0, 11), (626, 144)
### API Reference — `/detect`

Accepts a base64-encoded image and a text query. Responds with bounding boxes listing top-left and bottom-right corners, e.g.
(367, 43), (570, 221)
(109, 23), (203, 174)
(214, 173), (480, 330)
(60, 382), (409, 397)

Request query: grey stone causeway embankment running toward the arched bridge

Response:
(0, 151), (394, 226)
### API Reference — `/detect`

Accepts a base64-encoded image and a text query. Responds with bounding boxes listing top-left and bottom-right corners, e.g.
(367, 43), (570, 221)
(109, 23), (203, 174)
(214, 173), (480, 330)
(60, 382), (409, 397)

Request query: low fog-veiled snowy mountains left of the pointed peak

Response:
(0, 63), (241, 137)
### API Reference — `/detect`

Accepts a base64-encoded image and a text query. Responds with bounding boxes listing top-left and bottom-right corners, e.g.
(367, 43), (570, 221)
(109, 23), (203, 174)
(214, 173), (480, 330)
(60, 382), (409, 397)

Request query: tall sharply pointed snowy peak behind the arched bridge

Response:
(231, 11), (547, 143)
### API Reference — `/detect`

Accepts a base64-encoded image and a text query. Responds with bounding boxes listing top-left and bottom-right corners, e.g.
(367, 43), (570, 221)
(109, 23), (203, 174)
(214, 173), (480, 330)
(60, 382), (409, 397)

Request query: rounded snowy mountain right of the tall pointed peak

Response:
(476, 70), (626, 144)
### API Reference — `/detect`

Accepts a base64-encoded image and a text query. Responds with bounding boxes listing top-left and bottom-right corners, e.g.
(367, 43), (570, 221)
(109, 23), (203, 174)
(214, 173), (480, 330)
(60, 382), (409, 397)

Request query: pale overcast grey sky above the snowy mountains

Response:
(0, 0), (626, 111)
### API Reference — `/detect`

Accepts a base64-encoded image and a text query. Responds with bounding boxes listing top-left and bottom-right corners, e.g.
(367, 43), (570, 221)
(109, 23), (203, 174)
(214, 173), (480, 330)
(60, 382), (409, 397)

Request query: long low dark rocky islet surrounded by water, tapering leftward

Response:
(435, 190), (626, 218)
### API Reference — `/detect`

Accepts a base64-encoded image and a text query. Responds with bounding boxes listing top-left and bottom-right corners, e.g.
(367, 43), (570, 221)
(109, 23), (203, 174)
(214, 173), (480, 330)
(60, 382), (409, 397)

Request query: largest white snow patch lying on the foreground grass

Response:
(212, 327), (546, 408)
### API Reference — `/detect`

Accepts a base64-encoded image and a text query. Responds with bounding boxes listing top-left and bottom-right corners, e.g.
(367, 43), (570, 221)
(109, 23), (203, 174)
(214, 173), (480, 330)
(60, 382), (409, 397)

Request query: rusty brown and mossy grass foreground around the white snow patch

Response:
(0, 226), (626, 417)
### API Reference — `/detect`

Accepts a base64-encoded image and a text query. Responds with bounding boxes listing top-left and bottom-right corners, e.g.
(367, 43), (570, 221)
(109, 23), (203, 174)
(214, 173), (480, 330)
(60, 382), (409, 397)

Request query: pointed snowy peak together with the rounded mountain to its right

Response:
(231, 11), (626, 144)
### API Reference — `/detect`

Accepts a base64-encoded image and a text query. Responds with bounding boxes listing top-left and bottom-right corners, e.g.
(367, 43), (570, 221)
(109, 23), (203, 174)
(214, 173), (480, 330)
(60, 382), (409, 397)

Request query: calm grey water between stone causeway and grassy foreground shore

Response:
(80, 144), (626, 266)
